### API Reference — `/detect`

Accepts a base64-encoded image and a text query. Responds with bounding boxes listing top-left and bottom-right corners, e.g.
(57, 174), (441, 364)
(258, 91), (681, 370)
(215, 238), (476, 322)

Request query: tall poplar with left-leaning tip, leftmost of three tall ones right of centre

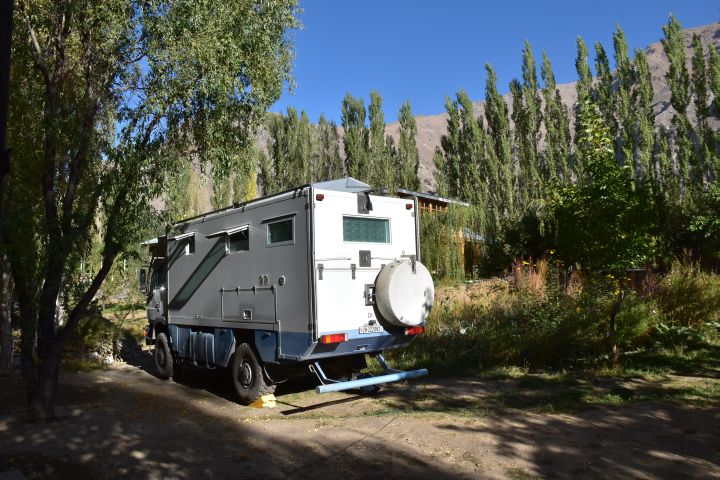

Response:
(485, 63), (515, 217)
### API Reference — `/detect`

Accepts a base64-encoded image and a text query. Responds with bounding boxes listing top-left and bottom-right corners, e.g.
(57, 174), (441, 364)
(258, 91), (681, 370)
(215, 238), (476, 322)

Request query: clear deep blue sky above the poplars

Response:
(271, 0), (720, 124)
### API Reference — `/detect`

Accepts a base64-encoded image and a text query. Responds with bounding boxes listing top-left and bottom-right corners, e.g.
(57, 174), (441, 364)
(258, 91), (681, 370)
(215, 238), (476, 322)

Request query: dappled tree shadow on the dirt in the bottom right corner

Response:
(442, 403), (720, 479)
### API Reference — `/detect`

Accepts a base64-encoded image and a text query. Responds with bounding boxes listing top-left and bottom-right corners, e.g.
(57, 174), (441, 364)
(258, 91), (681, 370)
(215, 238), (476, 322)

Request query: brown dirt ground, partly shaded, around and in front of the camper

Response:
(0, 350), (720, 479)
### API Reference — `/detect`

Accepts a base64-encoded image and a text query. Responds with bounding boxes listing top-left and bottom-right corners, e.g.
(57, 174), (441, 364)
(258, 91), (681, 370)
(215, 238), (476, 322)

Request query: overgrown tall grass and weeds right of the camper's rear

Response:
(390, 261), (720, 374)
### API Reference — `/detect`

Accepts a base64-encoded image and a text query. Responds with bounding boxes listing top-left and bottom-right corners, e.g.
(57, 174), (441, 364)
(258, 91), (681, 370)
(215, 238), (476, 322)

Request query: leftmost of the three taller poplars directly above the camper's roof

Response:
(342, 93), (371, 181)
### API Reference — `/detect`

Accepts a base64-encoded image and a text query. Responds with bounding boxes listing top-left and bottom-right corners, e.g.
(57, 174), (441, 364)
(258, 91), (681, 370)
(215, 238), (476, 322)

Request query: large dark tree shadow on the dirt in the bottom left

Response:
(0, 371), (464, 479)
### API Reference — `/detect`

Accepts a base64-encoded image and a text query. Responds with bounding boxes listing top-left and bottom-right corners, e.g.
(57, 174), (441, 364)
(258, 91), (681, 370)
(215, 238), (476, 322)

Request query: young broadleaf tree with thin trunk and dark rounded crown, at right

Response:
(552, 102), (655, 364)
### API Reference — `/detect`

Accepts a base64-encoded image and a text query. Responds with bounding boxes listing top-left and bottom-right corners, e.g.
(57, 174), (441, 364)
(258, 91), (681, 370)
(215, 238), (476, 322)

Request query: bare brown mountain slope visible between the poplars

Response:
(385, 23), (720, 192)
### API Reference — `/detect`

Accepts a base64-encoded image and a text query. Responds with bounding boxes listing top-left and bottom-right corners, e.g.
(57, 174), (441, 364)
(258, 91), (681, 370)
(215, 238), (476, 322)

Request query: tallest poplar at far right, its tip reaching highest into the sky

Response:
(661, 15), (699, 192)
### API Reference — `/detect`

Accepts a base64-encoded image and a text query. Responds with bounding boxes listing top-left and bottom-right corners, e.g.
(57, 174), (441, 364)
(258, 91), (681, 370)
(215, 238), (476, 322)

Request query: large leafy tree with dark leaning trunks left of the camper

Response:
(2, 0), (298, 420)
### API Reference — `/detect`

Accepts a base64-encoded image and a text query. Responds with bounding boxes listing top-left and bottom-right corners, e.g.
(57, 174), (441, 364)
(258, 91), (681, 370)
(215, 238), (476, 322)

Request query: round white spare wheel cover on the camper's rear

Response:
(375, 258), (435, 327)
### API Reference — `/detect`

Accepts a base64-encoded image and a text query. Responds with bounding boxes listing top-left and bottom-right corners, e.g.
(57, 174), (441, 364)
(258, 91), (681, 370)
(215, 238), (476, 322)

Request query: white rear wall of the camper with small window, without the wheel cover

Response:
(313, 189), (417, 343)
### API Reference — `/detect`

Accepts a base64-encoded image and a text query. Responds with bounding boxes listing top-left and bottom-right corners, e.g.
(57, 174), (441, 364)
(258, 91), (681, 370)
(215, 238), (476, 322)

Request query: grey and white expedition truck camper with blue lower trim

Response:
(140, 178), (434, 404)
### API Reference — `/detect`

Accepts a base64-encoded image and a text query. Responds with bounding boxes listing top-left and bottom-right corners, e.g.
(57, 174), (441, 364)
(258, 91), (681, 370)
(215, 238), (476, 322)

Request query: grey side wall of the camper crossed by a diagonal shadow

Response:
(168, 189), (312, 361)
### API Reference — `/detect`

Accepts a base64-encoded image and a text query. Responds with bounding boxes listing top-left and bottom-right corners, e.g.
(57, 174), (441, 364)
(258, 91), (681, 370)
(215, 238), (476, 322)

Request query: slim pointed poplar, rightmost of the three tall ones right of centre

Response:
(540, 52), (570, 182)
